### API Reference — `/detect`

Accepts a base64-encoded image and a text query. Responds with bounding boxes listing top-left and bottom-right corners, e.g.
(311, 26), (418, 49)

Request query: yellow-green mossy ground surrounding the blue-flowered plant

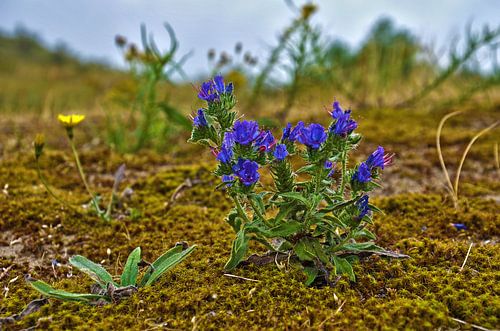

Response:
(0, 100), (500, 330)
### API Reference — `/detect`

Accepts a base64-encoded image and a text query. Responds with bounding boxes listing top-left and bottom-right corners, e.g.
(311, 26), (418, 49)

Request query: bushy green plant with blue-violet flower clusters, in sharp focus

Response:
(190, 76), (402, 285)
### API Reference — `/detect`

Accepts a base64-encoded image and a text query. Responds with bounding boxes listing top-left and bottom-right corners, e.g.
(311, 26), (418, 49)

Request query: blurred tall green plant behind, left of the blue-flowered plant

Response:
(106, 24), (191, 152)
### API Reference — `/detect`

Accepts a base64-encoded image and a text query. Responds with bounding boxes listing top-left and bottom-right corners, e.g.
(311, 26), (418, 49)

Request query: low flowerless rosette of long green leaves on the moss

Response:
(26, 243), (196, 304)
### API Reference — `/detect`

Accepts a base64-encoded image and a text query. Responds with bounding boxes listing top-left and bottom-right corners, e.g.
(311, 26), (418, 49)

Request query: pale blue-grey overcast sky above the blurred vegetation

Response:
(0, 0), (500, 74)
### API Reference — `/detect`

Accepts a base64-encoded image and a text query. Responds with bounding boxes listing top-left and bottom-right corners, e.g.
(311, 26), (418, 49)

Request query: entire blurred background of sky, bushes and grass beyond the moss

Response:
(0, 0), (500, 152)
